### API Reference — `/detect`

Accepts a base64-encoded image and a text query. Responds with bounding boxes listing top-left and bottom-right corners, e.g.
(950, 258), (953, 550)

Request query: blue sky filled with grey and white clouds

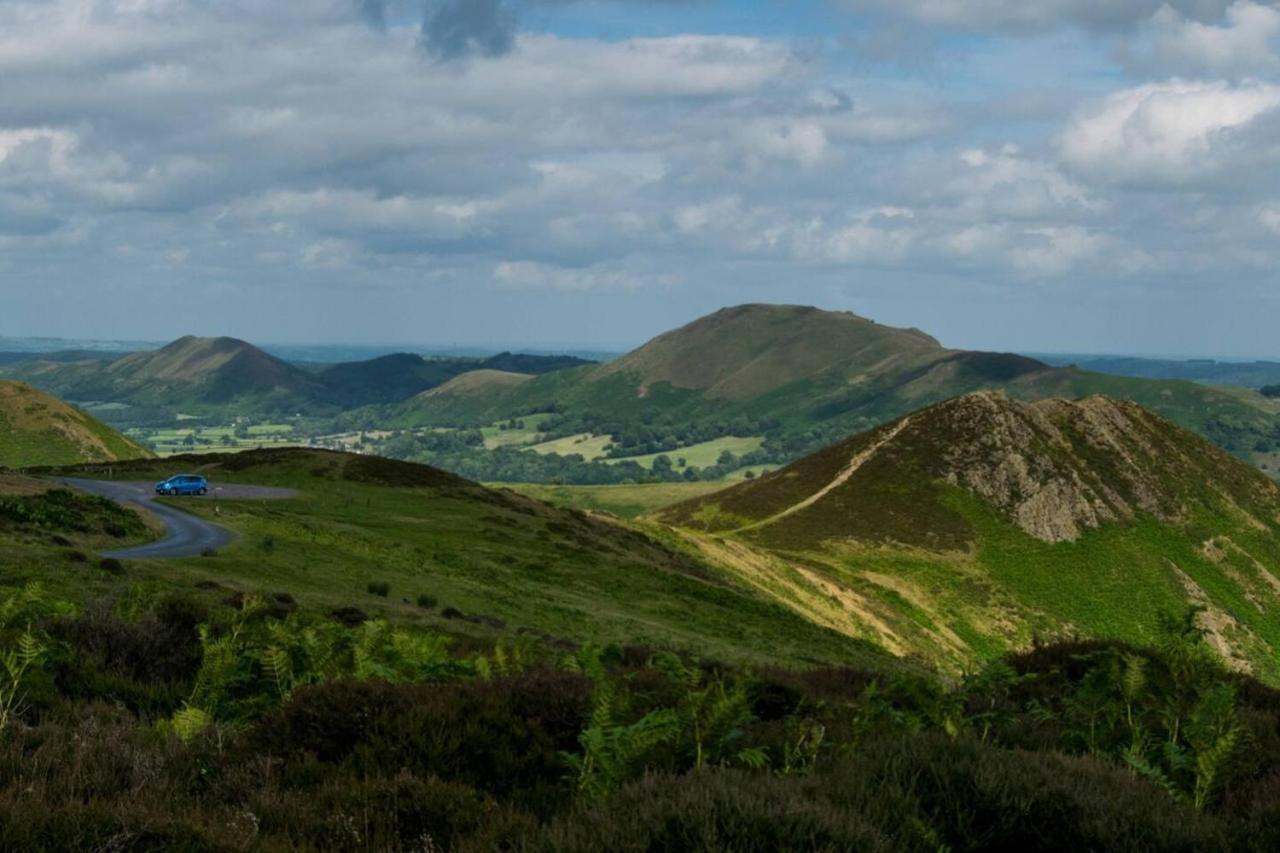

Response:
(0, 0), (1280, 357)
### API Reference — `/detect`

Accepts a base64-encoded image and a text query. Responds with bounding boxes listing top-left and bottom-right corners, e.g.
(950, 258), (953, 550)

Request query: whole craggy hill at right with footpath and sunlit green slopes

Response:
(655, 392), (1280, 680)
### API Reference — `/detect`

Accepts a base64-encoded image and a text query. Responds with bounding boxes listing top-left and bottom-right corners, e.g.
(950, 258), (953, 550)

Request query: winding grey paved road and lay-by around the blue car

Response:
(59, 476), (297, 560)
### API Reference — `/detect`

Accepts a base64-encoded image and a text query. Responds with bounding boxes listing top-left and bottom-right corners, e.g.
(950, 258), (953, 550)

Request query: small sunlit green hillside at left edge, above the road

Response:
(0, 380), (151, 467)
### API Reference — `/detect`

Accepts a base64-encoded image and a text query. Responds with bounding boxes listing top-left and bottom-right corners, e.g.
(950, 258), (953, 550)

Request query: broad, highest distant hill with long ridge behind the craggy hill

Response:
(385, 305), (1280, 459)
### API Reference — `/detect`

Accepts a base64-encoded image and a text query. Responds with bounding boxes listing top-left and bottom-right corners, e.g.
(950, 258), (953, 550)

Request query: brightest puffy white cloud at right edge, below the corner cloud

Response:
(1060, 81), (1280, 187)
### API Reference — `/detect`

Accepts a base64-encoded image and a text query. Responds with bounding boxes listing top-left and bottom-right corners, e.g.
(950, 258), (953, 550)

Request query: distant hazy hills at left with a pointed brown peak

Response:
(5, 336), (590, 420)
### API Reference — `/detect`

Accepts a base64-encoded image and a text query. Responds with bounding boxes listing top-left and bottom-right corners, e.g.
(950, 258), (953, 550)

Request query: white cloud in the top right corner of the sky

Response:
(1121, 0), (1280, 77)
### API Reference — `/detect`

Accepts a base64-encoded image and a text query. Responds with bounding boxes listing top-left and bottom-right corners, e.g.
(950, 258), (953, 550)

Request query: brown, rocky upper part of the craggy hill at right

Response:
(666, 392), (1280, 547)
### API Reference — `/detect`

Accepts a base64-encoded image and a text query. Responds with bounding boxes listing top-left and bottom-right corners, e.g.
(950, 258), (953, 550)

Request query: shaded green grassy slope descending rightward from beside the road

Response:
(15, 451), (886, 665)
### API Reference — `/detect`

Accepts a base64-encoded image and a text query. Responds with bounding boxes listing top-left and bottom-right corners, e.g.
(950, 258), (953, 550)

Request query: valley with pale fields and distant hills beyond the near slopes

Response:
(10, 305), (1280, 485)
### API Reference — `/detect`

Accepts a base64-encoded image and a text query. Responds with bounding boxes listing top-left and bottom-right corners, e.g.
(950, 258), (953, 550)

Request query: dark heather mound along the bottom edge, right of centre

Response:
(537, 734), (1229, 853)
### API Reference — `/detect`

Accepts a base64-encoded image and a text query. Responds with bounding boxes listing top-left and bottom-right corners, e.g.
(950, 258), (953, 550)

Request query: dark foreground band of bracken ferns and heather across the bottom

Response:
(0, 578), (1280, 853)
